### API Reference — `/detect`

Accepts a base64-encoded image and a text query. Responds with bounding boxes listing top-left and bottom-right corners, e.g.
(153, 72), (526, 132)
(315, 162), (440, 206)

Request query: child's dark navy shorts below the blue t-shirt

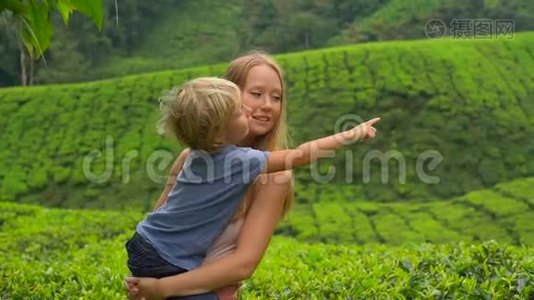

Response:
(126, 232), (217, 300)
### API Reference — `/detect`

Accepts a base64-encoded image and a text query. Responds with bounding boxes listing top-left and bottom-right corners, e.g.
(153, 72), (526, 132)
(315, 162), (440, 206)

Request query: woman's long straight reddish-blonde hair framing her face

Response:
(224, 51), (294, 217)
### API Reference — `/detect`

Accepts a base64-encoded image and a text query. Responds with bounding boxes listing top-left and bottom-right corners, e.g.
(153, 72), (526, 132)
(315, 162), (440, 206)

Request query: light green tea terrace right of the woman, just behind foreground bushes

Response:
(277, 178), (534, 246)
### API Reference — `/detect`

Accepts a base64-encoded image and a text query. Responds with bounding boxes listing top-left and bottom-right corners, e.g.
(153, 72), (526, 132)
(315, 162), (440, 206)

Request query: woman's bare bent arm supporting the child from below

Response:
(127, 171), (291, 299)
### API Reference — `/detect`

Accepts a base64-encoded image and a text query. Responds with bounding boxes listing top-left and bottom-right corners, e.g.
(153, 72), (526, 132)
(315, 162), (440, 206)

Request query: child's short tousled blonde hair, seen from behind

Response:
(157, 77), (241, 153)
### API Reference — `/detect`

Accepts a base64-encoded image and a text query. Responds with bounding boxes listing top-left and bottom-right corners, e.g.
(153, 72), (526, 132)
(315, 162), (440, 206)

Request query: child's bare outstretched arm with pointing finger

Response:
(262, 118), (380, 173)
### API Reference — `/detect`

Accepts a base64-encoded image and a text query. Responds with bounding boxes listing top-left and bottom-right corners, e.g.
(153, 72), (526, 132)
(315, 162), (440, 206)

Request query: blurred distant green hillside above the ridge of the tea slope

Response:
(4, 0), (534, 86)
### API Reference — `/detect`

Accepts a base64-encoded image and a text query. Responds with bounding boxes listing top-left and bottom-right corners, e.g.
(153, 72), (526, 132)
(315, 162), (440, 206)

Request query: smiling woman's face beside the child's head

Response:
(241, 65), (282, 138)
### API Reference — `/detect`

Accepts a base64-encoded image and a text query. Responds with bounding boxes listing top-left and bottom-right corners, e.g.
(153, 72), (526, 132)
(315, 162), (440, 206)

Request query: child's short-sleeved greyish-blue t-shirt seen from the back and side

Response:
(137, 145), (269, 270)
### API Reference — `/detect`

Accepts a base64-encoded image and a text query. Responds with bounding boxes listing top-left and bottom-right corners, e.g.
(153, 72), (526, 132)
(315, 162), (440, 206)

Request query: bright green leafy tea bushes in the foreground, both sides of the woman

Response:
(0, 203), (534, 299)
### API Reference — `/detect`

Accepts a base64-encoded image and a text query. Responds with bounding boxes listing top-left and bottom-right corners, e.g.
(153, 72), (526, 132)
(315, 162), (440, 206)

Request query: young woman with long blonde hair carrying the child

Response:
(126, 52), (374, 299)
